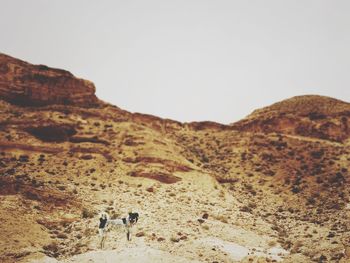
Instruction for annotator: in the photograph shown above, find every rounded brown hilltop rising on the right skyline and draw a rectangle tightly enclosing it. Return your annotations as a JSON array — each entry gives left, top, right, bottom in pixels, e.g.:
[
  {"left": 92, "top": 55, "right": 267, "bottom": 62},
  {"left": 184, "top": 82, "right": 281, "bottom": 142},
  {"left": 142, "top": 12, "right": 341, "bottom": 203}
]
[{"left": 232, "top": 95, "right": 350, "bottom": 142}]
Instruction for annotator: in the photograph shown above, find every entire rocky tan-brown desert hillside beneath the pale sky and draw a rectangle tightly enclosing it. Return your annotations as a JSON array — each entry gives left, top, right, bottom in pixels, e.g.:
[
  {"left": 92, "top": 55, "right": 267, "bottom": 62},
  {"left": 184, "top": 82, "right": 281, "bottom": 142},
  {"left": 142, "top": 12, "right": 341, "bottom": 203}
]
[{"left": 0, "top": 54, "right": 350, "bottom": 262}]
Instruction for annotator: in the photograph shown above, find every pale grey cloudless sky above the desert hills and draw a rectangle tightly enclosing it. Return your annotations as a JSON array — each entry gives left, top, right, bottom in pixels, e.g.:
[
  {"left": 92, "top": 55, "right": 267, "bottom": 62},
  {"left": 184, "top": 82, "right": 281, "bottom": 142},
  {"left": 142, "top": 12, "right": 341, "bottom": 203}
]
[{"left": 0, "top": 0, "right": 350, "bottom": 123}]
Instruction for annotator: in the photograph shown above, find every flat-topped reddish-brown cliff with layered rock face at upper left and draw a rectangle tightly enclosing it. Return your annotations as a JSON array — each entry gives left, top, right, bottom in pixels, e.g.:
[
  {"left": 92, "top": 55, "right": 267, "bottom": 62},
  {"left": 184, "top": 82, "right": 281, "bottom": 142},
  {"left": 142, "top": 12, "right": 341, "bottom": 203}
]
[{"left": 0, "top": 53, "right": 98, "bottom": 107}]
